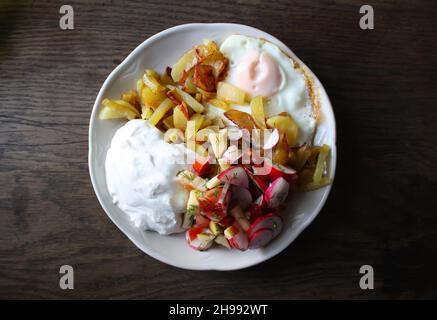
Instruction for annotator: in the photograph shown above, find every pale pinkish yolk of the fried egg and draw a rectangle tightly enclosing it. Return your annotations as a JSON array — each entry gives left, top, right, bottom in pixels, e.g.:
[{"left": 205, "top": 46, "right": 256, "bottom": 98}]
[{"left": 235, "top": 51, "right": 282, "bottom": 98}]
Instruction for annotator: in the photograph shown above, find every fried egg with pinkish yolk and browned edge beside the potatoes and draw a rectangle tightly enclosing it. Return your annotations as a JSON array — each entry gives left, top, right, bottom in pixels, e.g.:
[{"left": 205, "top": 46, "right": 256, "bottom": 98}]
[{"left": 211, "top": 35, "right": 316, "bottom": 144}]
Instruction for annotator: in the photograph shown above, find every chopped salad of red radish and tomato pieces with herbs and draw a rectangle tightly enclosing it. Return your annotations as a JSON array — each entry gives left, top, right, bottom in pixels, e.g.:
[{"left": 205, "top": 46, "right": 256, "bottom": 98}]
[{"left": 178, "top": 159, "right": 297, "bottom": 251}]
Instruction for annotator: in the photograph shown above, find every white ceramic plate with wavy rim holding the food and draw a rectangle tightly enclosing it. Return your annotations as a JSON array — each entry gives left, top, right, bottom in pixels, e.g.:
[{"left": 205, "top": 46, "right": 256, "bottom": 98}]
[{"left": 88, "top": 23, "right": 336, "bottom": 270}]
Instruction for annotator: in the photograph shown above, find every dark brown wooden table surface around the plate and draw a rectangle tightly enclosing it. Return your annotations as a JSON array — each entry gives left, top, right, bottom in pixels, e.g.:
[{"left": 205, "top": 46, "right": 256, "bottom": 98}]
[{"left": 0, "top": 0, "right": 437, "bottom": 299}]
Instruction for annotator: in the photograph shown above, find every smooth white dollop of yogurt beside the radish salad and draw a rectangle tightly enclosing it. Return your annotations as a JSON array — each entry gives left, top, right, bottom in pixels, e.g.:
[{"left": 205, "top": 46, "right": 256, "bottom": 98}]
[{"left": 105, "top": 120, "right": 188, "bottom": 234}]
